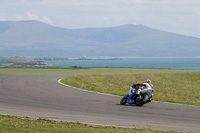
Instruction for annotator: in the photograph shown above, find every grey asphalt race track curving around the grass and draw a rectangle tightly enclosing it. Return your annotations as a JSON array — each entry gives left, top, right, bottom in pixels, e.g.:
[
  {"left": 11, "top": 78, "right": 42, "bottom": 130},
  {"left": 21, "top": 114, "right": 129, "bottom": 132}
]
[{"left": 0, "top": 75, "right": 200, "bottom": 132}]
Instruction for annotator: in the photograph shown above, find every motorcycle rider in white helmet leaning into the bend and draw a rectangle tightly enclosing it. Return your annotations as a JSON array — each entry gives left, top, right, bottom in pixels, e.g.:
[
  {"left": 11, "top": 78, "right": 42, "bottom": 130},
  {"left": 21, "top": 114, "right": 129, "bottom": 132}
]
[{"left": 129, "top": 79, "right": 153, "bottom": 97}]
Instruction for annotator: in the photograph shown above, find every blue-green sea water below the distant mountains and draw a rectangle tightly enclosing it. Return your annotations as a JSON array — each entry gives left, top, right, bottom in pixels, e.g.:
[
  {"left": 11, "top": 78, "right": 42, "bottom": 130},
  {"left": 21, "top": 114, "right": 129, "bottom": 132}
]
[{"left": 47, "top": 58, "right": 200, "bottom": 70}]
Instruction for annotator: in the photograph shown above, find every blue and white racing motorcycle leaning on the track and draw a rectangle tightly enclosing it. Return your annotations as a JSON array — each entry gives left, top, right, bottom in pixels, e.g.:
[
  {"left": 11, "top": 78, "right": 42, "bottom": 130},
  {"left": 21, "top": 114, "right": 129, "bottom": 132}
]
[{"left": 120, "top": 86, "right": 155, "bottom": 106}]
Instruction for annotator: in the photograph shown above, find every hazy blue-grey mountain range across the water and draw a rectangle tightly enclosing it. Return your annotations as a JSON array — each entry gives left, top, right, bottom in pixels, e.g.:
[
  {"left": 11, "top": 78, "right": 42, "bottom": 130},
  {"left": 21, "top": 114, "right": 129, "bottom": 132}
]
[{"left": 0, "top": 20, "right": 200, "bottom": 57}]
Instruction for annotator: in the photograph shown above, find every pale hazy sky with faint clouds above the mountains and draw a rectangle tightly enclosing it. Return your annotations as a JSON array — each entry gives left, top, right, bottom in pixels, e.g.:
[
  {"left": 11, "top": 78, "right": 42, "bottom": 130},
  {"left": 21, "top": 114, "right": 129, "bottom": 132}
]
[{"left": 0, "top": 0, "right": 200, "bottom": 38}]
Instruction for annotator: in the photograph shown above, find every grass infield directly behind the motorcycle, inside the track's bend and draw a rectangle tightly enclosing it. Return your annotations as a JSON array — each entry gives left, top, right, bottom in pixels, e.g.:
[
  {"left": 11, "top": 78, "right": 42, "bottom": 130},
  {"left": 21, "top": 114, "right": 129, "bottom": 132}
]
[{"left": 62, "top": 73, "right": 200, "bottom": 106}]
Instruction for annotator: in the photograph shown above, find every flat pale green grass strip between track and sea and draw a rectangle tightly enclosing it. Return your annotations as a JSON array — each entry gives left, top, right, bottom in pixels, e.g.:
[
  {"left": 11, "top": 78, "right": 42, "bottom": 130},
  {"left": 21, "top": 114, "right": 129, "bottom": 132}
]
[{"left": 0, "top": 67, "right": 200, "bottom": 76}]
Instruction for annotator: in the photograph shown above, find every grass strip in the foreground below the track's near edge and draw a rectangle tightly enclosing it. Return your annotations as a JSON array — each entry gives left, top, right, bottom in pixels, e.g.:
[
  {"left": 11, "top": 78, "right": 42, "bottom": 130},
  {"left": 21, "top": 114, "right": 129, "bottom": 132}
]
[{"left": 0, "top": 115, "right": 183, "bottom": 133}]
